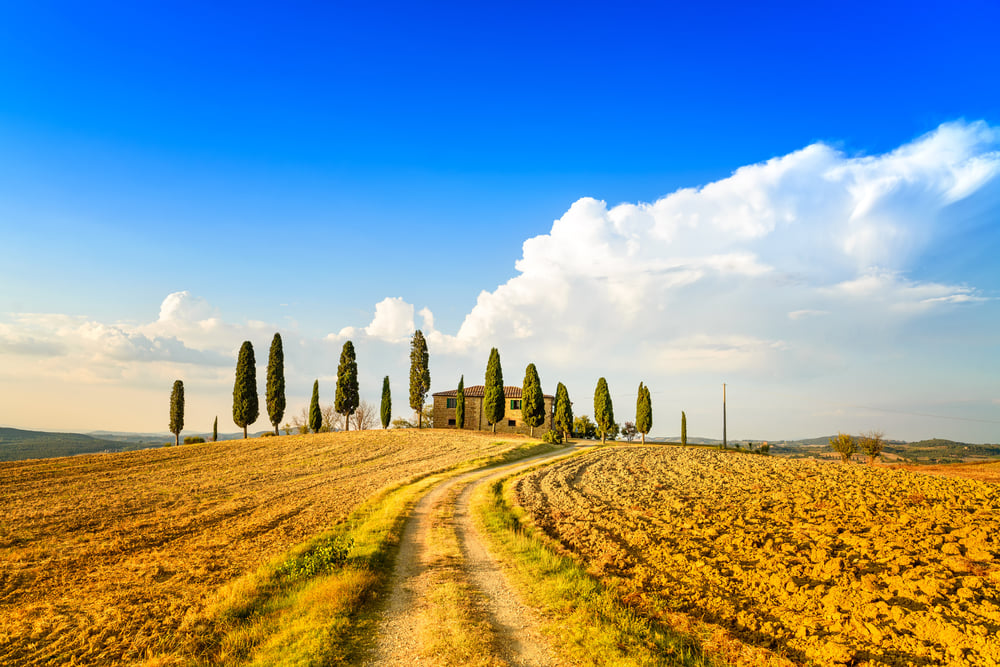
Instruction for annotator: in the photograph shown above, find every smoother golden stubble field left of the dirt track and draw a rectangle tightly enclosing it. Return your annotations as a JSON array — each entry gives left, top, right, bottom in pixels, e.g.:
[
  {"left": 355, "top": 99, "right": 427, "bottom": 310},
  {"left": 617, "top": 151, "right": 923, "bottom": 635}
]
[{"left": 0, "top": 430, "right": 518, "bottom": 665}]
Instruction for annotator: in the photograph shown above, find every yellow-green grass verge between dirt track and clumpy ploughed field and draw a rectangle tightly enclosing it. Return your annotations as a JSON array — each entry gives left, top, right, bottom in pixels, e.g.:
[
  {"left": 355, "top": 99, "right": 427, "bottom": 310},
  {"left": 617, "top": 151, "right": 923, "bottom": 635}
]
[{"left": 472, "top": 477, "right": 716, "bottom": 667}]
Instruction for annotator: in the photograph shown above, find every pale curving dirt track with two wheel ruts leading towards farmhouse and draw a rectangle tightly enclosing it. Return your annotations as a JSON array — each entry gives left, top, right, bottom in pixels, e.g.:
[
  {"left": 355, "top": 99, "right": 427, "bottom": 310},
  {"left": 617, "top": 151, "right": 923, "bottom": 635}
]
[{"left": 364, "top": 448, "right": 575, "bottom": 667}]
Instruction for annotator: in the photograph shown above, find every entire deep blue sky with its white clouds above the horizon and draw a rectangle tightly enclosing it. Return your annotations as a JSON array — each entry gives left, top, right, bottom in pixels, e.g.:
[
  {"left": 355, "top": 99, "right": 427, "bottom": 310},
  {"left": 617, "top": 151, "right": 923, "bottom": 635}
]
[{"left": 0, "top": 2, "right": 1000, "bottom": 442}]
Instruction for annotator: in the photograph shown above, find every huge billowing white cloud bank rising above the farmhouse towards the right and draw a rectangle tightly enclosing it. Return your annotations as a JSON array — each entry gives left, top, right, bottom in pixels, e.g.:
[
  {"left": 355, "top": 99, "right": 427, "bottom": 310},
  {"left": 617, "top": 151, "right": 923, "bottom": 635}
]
[{"left": 340, "top": 122, "right": 1000, "bottom": 380}]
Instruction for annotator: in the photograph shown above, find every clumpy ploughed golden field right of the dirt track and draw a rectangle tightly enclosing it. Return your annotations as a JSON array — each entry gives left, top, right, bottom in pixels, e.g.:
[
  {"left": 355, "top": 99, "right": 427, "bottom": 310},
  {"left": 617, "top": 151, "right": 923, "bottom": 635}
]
[{"left": 513, "top": 446, "right": 1000, "bottom": 665}]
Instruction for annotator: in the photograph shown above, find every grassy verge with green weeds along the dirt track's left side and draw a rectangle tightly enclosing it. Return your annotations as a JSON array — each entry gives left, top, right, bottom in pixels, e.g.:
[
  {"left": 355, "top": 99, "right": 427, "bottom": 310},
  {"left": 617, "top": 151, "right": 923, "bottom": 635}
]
[{"left": 144, "top": 443, "right": 556, "bottom": 667}]
